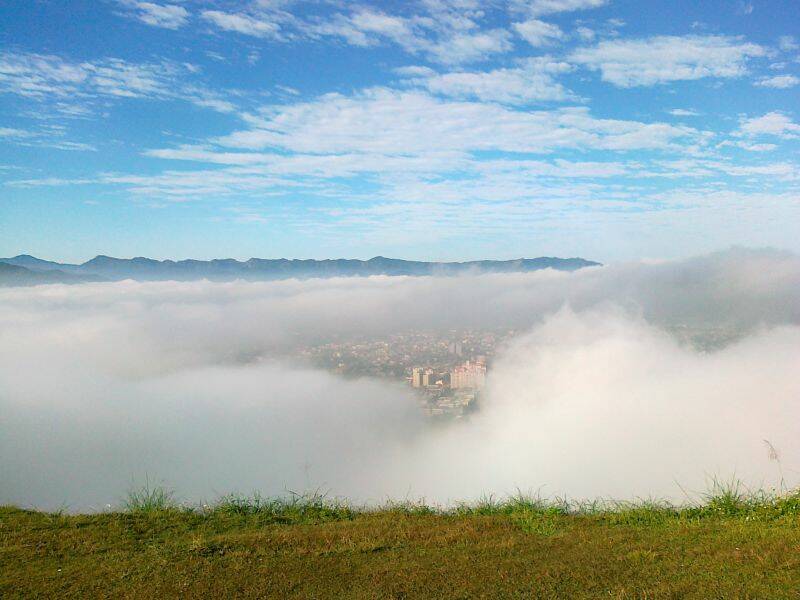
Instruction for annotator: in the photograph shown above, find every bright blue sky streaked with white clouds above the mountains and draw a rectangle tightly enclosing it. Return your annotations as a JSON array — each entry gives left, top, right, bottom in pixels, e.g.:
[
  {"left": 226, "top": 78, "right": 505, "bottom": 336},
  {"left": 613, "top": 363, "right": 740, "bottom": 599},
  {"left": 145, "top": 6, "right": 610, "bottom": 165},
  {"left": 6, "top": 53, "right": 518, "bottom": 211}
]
[{"left": 0, "top": 0, "right": 800, "bottom": 261}]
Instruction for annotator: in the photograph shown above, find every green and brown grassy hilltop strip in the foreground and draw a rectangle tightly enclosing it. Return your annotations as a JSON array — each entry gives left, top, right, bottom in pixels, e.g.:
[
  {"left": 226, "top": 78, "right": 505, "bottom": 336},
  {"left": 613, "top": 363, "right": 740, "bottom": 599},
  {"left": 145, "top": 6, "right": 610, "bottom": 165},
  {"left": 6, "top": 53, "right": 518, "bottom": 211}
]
[{"left": 0, "top": 482, "right": 800, "bottom": 598}]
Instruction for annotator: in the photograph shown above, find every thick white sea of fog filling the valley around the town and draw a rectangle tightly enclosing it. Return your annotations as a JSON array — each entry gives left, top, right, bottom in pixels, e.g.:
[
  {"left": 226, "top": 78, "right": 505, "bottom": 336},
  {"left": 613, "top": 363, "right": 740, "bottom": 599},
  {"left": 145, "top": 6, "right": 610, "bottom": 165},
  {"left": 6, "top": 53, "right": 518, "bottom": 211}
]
[{"left": 0, "top": 249, "right": 800, "bottom": 510}]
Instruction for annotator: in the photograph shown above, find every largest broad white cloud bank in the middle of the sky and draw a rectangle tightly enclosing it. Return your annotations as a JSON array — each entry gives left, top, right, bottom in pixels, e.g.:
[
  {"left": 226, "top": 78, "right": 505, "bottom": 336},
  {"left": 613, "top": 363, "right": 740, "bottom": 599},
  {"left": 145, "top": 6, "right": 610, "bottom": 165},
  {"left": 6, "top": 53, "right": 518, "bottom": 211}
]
[{"left": 216, "top": 88, "right": 699, "bottom": 154}]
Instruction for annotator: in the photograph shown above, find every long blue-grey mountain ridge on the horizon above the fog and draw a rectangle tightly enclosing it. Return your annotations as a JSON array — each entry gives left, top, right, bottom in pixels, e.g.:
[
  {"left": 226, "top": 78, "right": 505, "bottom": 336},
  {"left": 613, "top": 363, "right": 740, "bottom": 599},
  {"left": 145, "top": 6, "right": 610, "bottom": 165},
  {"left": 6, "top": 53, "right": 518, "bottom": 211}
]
[{"left": 0, "top": 254, "right": 600, "bottom": 285}]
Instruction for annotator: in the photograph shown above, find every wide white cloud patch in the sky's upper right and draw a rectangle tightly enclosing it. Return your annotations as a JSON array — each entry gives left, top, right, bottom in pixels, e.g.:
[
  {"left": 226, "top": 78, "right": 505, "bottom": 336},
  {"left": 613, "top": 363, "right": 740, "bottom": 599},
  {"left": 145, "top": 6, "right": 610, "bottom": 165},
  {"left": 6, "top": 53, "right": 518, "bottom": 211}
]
[{"left": 569, "top": 35, "right": 767, "bottom": 87}]
